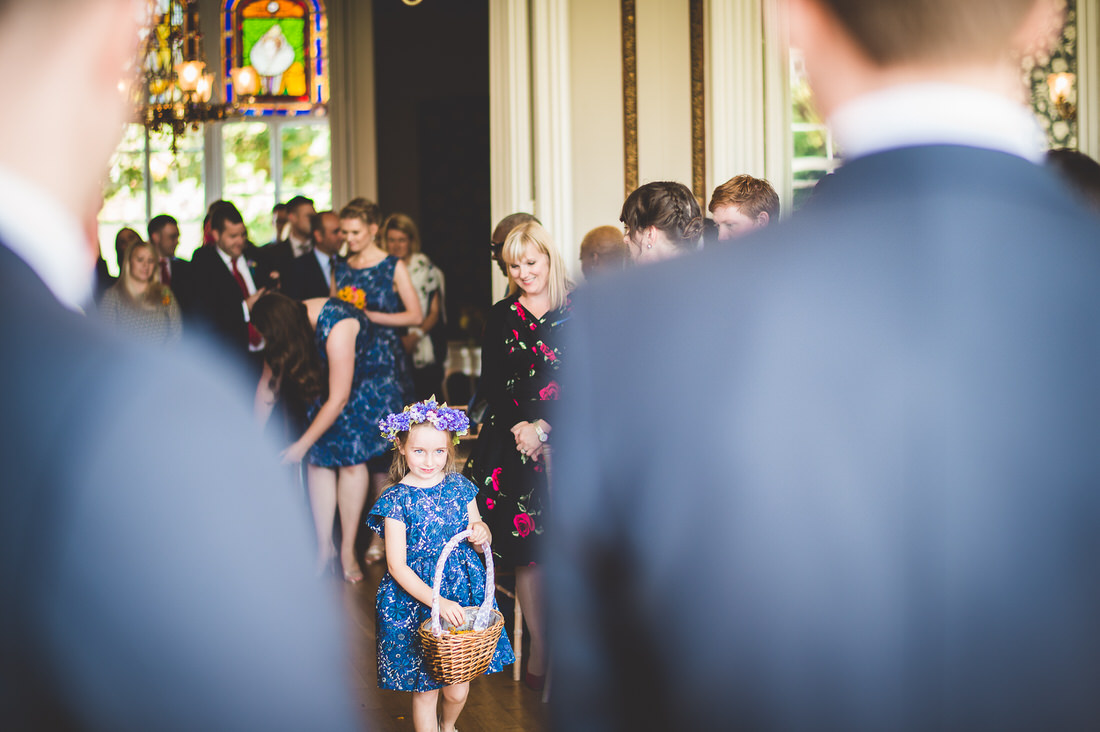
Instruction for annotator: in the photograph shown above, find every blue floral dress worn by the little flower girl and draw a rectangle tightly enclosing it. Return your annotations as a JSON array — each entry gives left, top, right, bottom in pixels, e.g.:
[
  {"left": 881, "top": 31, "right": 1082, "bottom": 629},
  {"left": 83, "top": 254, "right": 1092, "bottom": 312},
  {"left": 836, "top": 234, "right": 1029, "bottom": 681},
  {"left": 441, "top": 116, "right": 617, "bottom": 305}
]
[{"left": 366, "top": 473, "right": 516, "bottom": 691}]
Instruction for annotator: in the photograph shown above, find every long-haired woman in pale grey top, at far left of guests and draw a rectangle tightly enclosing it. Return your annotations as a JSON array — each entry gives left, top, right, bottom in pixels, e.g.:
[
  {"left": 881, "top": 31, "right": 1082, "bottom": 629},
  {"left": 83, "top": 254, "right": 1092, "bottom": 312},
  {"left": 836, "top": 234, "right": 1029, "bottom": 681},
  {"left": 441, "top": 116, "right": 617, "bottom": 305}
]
[{"left": 99, "top": 239, "right": 180, "bottom": 345}]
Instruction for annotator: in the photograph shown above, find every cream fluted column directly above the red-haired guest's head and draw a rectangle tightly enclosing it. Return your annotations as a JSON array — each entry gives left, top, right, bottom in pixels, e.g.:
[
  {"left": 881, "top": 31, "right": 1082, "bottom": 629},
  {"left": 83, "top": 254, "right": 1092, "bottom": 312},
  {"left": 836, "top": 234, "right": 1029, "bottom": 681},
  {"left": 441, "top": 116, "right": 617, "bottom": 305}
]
[{"left": 704, "top": 0, "right": 767, "bottom": 193}]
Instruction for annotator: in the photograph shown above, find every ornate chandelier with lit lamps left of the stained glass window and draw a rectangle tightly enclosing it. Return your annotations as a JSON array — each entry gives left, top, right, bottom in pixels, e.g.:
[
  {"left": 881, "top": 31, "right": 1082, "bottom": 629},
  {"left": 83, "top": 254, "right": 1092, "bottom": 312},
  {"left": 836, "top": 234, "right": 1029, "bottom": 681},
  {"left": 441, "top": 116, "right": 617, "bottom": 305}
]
[{"left": 134, "top": 0, "right": 229, "bottom": 152}]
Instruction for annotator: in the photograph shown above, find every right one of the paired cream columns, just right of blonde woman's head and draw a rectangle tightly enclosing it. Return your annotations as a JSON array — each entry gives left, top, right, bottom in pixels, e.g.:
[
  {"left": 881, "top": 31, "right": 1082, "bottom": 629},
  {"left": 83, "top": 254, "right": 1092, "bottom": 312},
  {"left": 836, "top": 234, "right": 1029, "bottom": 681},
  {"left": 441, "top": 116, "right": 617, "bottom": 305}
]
[{"left": 531, "top": 0, "right": 580, "bottom": 265}]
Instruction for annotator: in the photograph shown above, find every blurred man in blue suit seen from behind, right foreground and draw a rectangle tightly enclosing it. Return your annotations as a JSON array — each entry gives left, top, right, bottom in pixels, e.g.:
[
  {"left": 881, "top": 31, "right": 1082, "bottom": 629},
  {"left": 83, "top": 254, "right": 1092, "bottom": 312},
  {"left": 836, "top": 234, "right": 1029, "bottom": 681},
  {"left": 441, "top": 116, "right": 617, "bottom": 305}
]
[{"left": 547, "top": 0, "right": 1100, "bottom": 732}]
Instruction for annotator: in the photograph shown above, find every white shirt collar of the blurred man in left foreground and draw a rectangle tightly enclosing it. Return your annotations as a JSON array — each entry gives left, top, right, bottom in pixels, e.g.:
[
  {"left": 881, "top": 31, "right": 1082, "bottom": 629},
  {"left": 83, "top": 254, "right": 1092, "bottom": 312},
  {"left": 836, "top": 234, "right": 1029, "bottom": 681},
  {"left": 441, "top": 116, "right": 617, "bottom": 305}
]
[{"left": 0, "top": 166, "right": 95, "bottom": 310}]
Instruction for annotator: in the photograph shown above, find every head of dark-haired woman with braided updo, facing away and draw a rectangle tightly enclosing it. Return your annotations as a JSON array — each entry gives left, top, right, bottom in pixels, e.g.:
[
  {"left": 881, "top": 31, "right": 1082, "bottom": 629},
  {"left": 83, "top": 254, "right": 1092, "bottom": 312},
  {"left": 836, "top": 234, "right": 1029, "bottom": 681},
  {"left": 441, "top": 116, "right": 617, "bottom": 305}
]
[{"left": 619, "top": 181, "right": 703, "bottom": 263}]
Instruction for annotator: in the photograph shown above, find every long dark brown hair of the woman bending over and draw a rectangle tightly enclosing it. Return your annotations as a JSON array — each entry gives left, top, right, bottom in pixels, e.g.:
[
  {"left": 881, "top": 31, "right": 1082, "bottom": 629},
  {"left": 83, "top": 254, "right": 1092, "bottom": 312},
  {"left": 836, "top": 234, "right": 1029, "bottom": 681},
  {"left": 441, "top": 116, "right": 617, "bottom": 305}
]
[{"left": 252, "top": 293, "right": 322, "bottom": 405}]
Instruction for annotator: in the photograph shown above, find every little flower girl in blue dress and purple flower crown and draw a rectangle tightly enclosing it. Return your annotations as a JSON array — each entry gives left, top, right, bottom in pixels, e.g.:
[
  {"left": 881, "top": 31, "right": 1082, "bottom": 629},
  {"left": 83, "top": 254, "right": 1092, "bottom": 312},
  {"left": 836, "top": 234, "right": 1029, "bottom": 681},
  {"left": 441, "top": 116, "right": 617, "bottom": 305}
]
[{"left": 367, "top": 398, "right": 515, "bottom": 732}]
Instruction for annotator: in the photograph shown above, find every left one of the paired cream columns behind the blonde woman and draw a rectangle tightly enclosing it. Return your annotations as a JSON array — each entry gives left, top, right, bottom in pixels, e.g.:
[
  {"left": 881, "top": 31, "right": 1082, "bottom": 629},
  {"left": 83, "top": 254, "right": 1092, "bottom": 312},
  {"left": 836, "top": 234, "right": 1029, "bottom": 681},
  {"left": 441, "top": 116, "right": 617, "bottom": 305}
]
[{"left": 485, "top": 0, "right": 535, "bottom": 302}]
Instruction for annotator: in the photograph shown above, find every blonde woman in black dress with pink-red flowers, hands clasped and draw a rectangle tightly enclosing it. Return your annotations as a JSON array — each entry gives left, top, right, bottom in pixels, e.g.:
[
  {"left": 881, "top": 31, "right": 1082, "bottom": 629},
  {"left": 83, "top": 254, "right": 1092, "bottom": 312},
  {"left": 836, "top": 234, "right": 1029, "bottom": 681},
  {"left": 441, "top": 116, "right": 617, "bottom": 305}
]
[{"left": 465, "top": 221, "right": 572, "bottom": 689}]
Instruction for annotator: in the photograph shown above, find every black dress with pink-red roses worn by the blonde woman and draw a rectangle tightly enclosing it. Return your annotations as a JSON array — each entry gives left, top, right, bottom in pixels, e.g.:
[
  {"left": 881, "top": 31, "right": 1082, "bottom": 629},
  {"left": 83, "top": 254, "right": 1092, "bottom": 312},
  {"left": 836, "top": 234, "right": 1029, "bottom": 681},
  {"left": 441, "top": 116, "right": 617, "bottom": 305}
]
[{"left": 464, "top": 295, "right": 572, "bottom": 567}]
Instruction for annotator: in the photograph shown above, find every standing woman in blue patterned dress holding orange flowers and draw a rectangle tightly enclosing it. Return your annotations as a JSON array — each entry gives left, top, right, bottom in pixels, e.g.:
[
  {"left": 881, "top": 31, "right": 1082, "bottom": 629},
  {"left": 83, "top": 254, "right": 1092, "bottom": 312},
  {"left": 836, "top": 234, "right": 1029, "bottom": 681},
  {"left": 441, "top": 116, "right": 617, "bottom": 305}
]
[{"left": 332, "top": 199, "right": 424, "bottom": 564}]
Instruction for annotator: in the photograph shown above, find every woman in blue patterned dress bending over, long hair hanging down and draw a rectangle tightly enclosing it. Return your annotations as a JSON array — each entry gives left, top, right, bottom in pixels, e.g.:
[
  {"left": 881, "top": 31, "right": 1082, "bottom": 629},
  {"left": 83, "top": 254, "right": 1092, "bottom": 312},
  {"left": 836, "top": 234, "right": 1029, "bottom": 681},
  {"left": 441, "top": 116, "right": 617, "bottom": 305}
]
[{"left": 252, "top": 293, "right": 411, "bottom": 583}]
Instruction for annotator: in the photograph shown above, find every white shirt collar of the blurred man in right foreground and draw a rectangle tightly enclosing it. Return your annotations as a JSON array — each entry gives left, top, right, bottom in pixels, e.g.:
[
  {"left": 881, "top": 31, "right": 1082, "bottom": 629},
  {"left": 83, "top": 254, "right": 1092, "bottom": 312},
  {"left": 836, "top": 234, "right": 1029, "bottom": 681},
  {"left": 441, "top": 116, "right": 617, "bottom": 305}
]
[{"left": 828, "top": 83, "right": 1046, "bottom": 163}]
